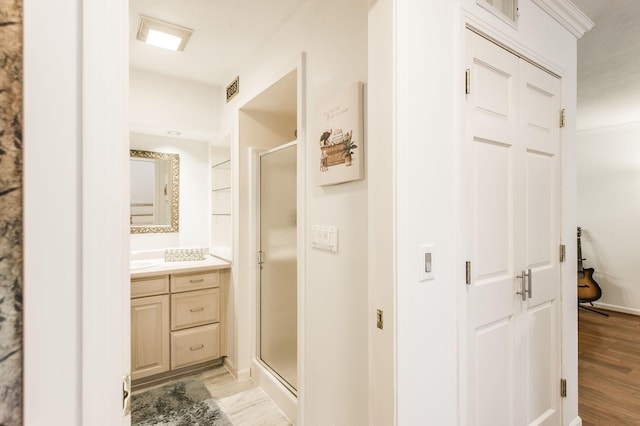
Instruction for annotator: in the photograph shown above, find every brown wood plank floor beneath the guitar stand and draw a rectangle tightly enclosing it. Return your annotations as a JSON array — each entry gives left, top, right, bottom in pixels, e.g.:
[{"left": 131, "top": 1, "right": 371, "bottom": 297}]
[{"left": 578, "top": 309, "right": 640, "bottom": 426}]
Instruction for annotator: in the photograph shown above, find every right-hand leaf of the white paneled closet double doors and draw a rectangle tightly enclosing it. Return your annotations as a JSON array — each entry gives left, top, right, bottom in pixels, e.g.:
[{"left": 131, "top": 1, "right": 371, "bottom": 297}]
[{"left": 516, "top": 55, "right": 562, "bottom": 425}]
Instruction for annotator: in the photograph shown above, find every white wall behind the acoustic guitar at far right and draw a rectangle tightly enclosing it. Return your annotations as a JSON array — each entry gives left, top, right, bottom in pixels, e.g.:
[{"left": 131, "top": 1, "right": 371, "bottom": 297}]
[{"left": 576, "top": 123, "right": 640, "bottom": 314}]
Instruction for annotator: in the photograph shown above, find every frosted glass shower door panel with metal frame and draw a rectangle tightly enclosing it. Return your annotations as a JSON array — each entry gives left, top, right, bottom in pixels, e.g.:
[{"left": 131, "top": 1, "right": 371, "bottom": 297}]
[{"left": 258, "top": 142, "right": 298, "bottom": 393}]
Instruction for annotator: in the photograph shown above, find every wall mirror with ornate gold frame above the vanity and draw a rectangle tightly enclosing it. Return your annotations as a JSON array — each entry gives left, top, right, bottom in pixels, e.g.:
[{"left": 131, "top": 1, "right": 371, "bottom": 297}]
[{"left": 129, "top": 149, "right": 180, "bottom": 234}]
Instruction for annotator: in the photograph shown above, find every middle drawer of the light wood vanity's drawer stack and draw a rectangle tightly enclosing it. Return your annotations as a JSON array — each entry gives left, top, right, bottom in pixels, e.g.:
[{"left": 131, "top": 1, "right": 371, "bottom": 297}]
[{"left": 171, "top": 288, "right": 220, "bottom": 330}]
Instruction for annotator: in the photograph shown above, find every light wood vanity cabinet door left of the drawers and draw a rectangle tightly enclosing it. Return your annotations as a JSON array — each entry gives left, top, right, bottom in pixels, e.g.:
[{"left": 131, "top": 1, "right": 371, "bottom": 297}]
[{"left": 131, "top": 294, "right": 169, "bottom": 380}]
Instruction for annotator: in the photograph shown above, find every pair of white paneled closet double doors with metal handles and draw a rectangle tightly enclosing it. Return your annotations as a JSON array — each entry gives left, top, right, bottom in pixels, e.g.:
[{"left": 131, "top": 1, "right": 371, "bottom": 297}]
[{"left": 463, "top": 31, "right": 560, "bottom": 426}]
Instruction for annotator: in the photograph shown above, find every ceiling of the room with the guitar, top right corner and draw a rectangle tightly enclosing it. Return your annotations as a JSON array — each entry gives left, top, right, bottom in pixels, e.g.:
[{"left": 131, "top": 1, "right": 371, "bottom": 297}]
[{"left": 572, "top": 0, "right": 640, "bottom": 130}]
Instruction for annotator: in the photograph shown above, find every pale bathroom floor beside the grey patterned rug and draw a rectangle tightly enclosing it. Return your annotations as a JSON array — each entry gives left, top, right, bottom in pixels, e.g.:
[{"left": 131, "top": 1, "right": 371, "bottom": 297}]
[{"left": 133, "top": 365, "right": 292, "bottom": 426}]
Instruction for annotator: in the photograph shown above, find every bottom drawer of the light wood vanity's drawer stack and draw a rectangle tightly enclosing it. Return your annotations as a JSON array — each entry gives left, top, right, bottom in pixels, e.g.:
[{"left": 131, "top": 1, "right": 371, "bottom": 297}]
[{"left": 171, "top": 324, "right": 220, "bottom": 369}]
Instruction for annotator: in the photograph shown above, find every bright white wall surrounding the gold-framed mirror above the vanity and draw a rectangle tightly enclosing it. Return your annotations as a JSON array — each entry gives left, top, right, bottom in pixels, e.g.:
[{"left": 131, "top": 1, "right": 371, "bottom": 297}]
[{"left": 130, "top": 133, "right": 211, "bottom": 250}]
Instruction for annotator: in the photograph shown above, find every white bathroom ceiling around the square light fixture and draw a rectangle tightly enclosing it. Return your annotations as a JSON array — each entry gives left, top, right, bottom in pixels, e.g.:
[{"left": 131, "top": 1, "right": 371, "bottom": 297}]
[{"left": 129, "top": 0, "right": 307, "bottom": 87}]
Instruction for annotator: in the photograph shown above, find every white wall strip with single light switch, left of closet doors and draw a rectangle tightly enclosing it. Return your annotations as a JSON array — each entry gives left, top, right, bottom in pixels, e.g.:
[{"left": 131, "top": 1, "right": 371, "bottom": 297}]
[{"left": 395, "top": 0, "right": 462, "bottom": 425}]
